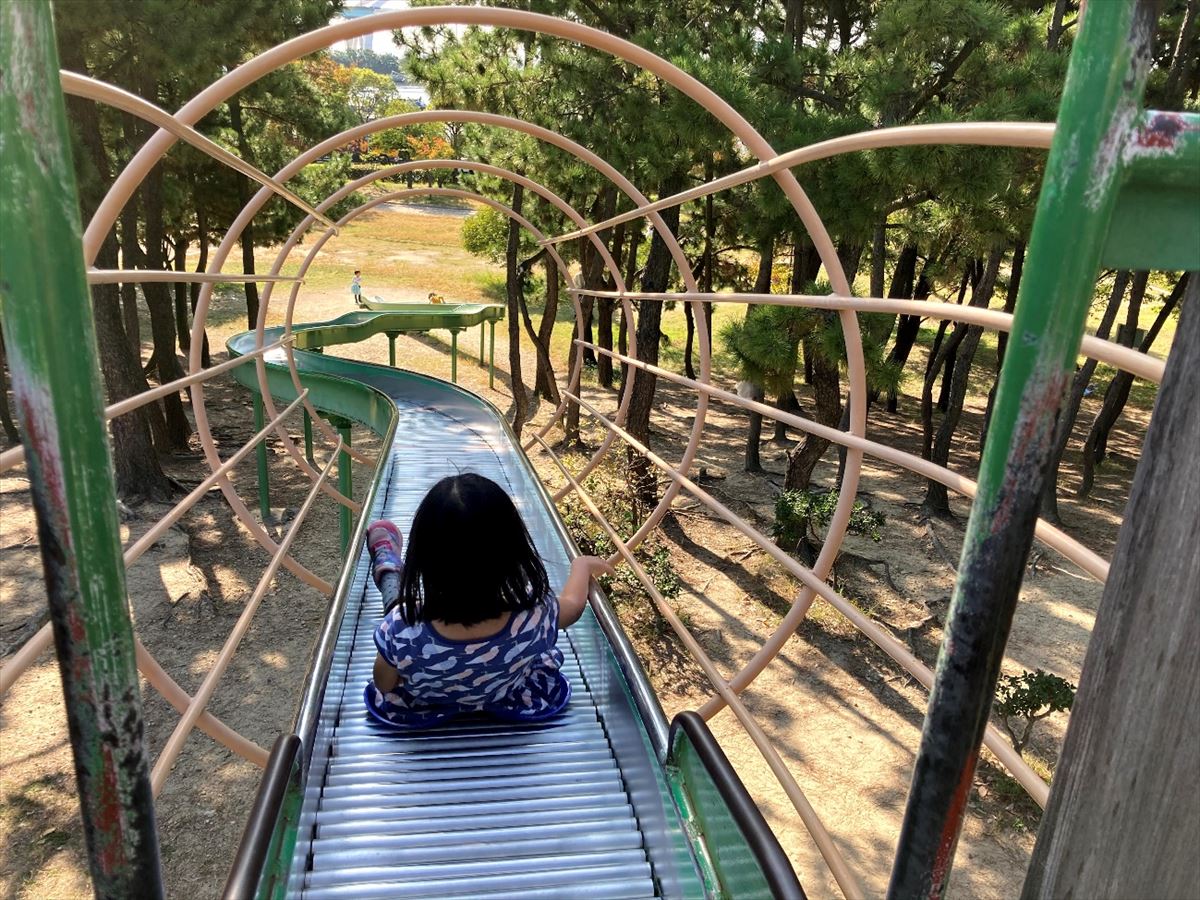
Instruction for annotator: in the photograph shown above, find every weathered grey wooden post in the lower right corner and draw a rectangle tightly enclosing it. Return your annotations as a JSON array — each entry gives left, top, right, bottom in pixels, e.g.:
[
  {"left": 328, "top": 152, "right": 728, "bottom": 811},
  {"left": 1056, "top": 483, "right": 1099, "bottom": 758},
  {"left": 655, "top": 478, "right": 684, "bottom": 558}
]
[{"left": 1021, "top": 278, "right": 1200, "bottom": 900}]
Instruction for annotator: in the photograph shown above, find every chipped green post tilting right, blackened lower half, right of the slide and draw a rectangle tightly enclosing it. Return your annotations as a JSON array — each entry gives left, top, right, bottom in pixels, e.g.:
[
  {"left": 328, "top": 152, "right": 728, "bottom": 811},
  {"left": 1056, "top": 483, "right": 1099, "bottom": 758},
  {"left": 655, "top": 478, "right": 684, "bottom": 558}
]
[{"left": 888, "top": 0, "right": 1154, "bottom": 898}]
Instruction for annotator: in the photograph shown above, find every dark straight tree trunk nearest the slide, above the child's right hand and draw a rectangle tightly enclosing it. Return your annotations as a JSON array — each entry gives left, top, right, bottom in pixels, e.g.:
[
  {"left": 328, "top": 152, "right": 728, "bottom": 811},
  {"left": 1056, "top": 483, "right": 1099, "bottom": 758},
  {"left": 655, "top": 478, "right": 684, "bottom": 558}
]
[{"left": 626, "top": 174, "right": 683, "bottom": 509}]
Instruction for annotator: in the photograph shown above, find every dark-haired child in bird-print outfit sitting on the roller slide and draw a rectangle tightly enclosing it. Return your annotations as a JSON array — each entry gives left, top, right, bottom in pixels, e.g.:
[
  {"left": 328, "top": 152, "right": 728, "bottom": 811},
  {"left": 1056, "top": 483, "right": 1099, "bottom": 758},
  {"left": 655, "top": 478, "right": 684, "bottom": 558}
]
[{"left": 364, "top": 473, "right": 613, "bottom": 727}]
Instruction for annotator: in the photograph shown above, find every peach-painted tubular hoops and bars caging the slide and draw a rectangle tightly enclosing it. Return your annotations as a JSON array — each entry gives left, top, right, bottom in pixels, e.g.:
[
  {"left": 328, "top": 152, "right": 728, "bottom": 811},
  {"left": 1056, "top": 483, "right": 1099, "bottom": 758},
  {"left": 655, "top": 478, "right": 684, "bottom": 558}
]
[{"left": 0, "top": 4, "right": 1185, "bottom": 896}]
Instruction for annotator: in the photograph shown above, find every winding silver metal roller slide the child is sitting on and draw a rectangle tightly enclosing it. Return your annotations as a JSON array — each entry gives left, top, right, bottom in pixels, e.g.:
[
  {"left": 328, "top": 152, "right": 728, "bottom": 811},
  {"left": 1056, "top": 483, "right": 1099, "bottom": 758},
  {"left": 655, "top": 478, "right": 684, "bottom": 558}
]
[{"left": 226, "top": 313, "right": 800, "bottom": 900}]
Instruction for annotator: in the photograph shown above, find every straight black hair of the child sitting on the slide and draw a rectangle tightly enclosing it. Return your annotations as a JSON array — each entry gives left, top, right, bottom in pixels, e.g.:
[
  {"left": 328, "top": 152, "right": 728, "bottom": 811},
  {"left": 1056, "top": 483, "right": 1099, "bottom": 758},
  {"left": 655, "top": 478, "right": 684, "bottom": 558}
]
[{"left": 398, "top": 472, "right": 550, "bottom": 626}]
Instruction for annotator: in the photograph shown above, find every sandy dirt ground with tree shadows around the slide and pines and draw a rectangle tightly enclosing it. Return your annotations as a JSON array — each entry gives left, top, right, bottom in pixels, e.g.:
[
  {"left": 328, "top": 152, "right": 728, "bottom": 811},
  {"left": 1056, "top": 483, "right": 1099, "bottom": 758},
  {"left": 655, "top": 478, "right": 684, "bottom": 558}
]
[{"left": 0, "top": 206, "right": 1146, "bottom": 900}]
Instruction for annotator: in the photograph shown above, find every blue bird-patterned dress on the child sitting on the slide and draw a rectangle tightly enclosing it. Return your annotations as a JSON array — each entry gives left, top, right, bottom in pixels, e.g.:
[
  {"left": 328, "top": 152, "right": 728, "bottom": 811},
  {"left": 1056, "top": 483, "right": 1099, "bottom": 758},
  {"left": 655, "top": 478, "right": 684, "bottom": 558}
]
[{"left": 364, "top": 596, "right": 571, "bottom": 728}]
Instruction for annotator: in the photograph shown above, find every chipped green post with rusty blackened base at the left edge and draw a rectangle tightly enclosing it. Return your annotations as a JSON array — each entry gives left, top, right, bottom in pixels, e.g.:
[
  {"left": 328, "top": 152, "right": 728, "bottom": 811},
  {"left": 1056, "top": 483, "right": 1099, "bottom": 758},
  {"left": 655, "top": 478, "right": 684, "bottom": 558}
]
[{"left": 0, "top": 1, "right": 162, "bottom": 898}]
